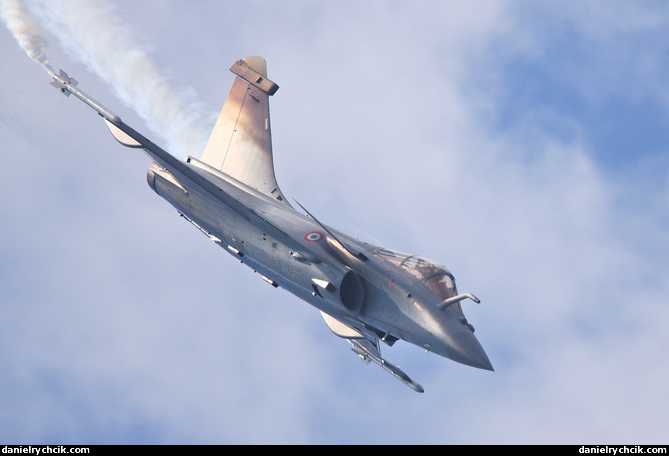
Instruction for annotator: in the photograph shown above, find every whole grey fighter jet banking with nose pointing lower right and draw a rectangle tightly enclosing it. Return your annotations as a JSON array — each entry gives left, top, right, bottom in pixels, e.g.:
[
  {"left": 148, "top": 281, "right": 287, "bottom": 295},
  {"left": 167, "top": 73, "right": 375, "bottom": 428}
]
[{"left": 51, "top": 57, "right": 493, "bottom": 393}]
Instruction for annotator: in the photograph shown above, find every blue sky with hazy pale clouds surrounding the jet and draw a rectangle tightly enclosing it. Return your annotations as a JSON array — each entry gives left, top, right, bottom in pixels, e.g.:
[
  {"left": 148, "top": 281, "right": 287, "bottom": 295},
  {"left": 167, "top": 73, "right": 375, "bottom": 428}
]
[{"left": 0, "top": 0, "right": 669, "bottom": 444}]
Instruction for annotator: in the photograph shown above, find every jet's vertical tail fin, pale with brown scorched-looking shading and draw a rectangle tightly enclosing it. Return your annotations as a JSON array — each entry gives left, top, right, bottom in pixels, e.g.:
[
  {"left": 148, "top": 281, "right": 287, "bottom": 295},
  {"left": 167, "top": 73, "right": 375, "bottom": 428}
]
[{"left": 202, "top": 57, "right": 288, "bottom": 204}]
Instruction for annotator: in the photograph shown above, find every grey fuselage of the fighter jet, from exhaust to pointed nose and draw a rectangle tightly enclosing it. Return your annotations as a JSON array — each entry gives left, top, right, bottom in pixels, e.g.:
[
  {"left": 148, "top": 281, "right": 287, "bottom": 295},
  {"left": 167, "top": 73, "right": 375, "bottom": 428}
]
[{"left": 147, "top": 158, "right": 492, "bottom": 370}]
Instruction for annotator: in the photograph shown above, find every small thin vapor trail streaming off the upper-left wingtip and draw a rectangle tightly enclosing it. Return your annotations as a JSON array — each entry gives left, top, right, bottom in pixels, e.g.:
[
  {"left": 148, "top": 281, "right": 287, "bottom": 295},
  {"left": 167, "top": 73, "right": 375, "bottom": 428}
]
[{"left": 0, "top": 0, "right": 53, "bottom": 74}]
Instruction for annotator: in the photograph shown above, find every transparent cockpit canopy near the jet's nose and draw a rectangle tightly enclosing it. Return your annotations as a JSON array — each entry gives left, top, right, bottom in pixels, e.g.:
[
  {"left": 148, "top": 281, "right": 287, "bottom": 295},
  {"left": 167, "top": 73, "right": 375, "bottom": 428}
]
[{"left": 374, "top": 249, "right": 460, "bottom": 308}]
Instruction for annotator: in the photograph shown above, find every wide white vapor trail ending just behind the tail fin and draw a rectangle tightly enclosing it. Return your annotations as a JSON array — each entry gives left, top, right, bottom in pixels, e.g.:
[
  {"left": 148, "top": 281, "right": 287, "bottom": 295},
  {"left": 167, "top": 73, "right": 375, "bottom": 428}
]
[{"left": 9, "top": 0, "right": 211, "bottom": 157}]
